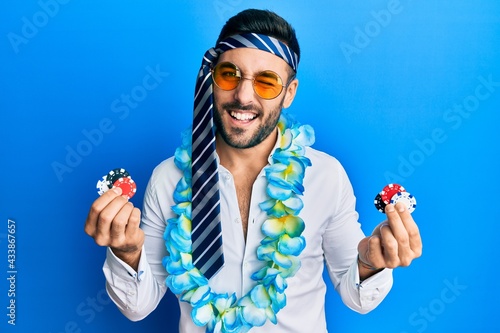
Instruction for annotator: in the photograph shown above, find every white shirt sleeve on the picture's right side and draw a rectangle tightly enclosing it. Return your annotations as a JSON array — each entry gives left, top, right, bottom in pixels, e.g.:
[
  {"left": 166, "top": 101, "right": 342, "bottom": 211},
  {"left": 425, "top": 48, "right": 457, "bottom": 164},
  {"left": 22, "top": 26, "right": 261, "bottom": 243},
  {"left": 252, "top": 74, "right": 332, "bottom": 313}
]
[{"left": 323, "top": 160, "right": 393, "bottom": 314}]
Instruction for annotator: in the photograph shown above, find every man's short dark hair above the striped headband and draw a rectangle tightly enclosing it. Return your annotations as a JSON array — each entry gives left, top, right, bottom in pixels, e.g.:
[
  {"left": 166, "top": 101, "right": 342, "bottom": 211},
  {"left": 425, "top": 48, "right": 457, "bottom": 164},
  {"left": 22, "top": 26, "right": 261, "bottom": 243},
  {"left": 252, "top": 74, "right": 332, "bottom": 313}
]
[{"left": 217, "top": 9, "right": 300, "bottom": 67}]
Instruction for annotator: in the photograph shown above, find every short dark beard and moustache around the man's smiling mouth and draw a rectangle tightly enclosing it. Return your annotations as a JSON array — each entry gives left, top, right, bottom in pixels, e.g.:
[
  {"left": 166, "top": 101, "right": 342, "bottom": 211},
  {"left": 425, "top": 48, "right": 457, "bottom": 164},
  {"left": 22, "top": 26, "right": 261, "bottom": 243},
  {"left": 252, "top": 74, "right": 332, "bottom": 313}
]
[{"left": 214, "top": 96, "right": 285, "bottom": 149}]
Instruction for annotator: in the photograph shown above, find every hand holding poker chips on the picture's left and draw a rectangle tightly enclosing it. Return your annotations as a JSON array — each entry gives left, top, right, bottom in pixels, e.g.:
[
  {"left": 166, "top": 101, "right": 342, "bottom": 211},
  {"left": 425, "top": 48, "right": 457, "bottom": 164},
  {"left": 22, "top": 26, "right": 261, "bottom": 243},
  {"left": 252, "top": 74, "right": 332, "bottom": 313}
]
[{"left": 85, "top": 187, "right": 144, "bottom": 270}]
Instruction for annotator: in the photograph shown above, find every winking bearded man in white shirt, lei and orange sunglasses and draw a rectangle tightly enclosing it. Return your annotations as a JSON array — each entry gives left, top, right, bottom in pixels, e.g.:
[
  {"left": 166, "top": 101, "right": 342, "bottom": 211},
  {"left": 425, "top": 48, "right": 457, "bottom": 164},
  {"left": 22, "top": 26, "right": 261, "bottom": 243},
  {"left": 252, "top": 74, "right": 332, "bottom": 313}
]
[{"left": 85, "top": 10, "right": 422, "bottom": 333}]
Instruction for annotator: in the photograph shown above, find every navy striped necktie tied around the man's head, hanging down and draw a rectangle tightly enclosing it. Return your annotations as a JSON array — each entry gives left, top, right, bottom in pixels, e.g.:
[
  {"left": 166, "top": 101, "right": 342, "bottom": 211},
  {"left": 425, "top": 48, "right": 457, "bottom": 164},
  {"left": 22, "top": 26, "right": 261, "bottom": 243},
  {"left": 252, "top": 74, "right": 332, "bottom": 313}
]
[{"left": 191, "top": 33, "right": 298, "bottom": 279}]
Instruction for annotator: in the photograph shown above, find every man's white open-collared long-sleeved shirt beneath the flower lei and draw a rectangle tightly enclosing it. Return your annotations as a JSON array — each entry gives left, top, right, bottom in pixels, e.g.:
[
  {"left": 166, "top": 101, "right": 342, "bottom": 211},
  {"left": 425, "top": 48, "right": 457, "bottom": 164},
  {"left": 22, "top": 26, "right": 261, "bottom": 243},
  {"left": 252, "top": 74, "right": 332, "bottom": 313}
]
[{"left": 103, "top": 134, "right": 392, "bottom": 333}]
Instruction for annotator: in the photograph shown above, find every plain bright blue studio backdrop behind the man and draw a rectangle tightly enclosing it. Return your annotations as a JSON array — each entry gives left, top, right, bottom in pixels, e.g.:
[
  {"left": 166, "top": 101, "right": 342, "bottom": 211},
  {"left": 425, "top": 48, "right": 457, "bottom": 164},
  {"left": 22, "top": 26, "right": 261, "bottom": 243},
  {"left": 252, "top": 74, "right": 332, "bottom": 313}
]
[{"left": 0, "top": 0, "right": 500, "bottom": 333}]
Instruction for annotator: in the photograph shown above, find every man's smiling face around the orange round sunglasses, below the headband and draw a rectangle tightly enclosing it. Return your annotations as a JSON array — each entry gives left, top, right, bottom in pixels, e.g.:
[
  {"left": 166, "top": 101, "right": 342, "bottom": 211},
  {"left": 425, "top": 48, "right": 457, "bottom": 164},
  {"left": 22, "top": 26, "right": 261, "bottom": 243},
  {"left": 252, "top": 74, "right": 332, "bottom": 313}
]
[{"left": 214, "top": 48, "right": 298, "bottom": 149}]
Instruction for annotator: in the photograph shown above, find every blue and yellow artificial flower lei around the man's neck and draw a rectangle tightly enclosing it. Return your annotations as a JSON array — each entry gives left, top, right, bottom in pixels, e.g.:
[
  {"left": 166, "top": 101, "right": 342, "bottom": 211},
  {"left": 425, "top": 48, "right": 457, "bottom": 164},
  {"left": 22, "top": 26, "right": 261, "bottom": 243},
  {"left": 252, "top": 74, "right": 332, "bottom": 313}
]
[{"left": 163, "top": 112, "right": 314, "bottom": 333}]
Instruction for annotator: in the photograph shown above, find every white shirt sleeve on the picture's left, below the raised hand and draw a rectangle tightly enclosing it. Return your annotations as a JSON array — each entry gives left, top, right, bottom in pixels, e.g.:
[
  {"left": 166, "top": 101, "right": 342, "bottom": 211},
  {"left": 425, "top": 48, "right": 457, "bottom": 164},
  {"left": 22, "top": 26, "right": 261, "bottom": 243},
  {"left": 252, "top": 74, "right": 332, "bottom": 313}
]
[{"left": 103, "top": 160, "right": 175, "bottom": 321}]
